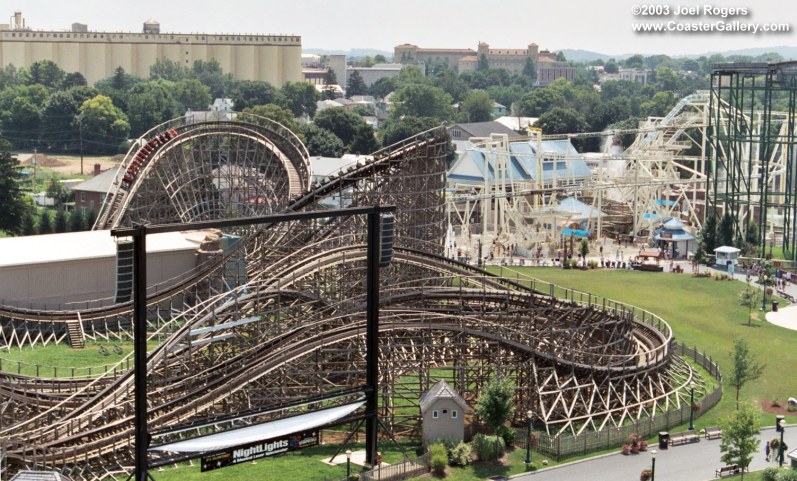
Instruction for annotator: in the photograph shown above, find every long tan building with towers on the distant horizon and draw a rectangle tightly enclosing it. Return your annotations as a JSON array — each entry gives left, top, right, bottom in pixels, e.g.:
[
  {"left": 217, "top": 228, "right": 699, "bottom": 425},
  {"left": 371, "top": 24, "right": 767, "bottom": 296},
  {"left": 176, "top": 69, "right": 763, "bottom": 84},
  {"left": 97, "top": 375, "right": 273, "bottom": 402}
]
[{"left": 393, "top": 42, "right": 576, "bottom": 86}]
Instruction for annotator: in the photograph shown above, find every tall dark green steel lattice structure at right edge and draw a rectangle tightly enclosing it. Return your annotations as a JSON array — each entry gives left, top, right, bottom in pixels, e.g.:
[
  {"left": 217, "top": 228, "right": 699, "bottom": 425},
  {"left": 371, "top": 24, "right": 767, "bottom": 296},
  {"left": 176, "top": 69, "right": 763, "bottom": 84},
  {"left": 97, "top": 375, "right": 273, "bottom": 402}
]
[{"left": 707, "top": 62, "right": 797, "bottom": 260}]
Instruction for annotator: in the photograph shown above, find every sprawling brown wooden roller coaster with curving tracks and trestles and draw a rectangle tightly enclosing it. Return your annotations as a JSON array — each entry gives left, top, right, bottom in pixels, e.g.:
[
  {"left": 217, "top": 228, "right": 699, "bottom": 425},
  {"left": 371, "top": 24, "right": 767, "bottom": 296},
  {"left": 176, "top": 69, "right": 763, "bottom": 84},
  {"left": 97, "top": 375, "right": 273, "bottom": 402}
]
[{"left": 0, "top": 116, "right": 700, "bottom": 480}]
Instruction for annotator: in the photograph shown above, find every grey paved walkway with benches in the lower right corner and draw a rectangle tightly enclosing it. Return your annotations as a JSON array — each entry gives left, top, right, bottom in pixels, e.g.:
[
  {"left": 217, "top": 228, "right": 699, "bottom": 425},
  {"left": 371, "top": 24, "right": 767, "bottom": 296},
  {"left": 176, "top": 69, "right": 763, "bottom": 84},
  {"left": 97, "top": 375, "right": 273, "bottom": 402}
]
[{"left": 512, "top": 426, "right": 797, "bottom": 481}]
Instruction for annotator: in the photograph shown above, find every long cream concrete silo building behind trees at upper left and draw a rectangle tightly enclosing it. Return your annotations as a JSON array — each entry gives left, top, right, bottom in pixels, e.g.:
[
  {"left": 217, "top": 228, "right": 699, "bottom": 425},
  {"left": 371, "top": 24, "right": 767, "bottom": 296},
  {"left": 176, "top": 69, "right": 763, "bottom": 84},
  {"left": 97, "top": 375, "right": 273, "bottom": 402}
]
[{"left": 0, "top": 12, "right": 302, "bottom": 86}]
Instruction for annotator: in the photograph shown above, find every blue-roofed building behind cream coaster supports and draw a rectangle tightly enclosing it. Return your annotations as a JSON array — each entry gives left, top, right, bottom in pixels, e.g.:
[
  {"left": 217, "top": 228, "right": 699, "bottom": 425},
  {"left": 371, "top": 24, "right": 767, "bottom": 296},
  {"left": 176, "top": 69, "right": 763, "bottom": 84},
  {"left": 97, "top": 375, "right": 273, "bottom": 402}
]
[{"left": 446, "top": 133, "right": 592, "bottom": 249}]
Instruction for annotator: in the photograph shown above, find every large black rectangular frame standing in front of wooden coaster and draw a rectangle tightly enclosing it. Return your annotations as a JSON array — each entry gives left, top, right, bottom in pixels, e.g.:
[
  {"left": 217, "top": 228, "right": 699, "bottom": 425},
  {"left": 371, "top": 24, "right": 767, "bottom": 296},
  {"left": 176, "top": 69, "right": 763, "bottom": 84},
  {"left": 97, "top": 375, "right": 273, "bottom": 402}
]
[{"left": 111, "top": 205, "right": 396, "bottom": 481}]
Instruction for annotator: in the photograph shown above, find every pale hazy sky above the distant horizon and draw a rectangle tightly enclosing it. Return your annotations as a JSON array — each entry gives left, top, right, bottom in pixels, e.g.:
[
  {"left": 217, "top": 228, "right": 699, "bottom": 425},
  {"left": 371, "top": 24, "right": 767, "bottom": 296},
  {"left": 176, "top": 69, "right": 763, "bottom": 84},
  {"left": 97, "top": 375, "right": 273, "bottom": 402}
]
[{"left": 6, "top": 0, "right": 797, "bottom": 56}]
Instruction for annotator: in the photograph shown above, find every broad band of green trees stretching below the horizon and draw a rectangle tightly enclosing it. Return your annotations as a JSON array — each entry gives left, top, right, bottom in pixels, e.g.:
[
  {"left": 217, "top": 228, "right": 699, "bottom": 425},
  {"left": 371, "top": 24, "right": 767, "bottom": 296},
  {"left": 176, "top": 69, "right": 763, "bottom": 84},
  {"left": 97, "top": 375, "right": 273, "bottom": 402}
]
[{"left": 0, "top": 49, "right": 782, "bottom": 233}]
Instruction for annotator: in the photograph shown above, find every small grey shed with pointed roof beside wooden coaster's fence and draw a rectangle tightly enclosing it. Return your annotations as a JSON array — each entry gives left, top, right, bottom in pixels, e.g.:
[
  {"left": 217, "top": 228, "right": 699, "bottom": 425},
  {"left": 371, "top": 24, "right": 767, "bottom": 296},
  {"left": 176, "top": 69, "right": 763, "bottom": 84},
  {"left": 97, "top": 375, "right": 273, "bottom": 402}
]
[{"left": 421, "top": 381, "right": 470, "bottom": 444}]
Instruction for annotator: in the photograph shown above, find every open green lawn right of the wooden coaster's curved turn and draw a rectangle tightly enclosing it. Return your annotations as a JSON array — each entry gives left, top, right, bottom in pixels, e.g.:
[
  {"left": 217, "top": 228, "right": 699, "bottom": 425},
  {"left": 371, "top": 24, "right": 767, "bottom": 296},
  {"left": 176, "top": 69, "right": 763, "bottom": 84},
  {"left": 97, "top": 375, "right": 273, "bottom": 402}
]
[{"left": 492, "top": 267, "right": 797, "bottom": 425}]
